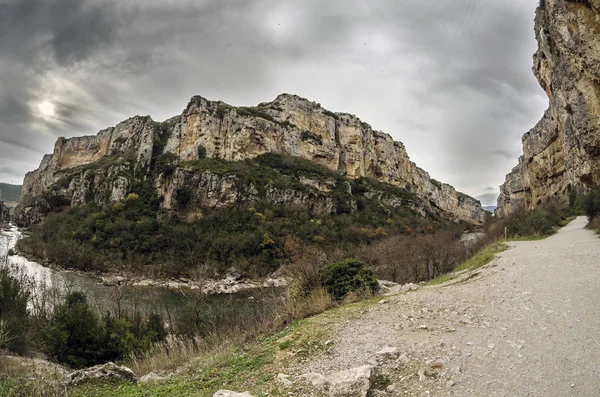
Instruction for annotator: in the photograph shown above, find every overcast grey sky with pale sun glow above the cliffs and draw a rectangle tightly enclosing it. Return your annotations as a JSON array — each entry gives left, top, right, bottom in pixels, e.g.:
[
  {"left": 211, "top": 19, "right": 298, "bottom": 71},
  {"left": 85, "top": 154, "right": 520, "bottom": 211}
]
[{"left": 0, "top": 0, "right": 548, "bottom": 204}]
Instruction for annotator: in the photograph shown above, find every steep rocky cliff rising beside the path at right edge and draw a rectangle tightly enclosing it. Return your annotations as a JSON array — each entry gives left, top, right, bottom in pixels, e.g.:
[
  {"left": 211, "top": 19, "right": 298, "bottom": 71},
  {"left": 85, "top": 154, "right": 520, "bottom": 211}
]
[{"left": 497, "top": 0, "right": 600, "bottom": 215}]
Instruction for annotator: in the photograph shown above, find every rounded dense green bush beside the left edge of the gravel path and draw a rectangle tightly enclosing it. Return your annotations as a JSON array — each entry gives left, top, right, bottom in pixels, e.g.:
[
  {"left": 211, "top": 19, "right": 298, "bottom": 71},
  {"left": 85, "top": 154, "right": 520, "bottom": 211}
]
[{"left": 321, "top": 259, "right": 379, "bottom": 300}]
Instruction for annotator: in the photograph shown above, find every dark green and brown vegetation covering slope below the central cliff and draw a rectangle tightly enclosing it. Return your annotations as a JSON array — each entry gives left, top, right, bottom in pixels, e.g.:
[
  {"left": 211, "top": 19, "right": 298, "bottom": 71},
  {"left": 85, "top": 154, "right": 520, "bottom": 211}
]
[{"left": 19, "top": 154, "right": 448, "bottom": 277}]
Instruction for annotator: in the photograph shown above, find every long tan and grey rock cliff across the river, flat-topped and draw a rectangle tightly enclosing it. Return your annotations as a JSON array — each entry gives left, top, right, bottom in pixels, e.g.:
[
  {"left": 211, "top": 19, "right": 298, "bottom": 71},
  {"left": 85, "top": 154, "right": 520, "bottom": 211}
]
[{"left": 16, "top": 94, "right": 485, "bottom": 225}]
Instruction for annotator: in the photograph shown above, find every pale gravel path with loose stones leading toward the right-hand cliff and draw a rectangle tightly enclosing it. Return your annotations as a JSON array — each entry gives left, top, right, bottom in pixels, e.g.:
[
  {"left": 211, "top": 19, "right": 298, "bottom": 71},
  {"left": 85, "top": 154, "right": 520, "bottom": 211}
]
[{"left": 290, "top": 217, "right": 600, "bottom": 397}]
